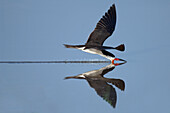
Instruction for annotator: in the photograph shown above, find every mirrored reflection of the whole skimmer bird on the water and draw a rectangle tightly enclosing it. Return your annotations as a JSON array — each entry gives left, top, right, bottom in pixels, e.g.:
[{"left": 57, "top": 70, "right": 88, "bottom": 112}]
[{"left": 65, "top": 63, "right": 125, "bottom": 108}]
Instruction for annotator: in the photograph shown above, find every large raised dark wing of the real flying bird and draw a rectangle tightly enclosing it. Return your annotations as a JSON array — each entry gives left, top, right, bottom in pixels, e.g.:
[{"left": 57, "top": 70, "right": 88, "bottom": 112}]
[{"left": 86, "top": 4, "right": 116, "bottom": 47}]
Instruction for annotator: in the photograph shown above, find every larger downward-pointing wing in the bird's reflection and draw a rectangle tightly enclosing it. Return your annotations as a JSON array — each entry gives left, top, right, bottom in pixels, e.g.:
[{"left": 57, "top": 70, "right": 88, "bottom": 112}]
[{"left": 87, "top": 78, "right": 117, "bottom": 108}]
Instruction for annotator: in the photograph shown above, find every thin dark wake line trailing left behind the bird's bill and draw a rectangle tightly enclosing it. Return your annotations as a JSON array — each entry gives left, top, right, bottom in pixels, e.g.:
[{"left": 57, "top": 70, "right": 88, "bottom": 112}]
[{"left": 0, "top": 60, "right": 110, "bottom": 64}]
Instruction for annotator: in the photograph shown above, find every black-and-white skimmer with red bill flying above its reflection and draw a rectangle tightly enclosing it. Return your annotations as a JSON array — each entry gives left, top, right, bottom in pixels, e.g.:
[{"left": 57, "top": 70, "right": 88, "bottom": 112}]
[{"left": 64, "top": 4, "right": 125, "bottom": 63}]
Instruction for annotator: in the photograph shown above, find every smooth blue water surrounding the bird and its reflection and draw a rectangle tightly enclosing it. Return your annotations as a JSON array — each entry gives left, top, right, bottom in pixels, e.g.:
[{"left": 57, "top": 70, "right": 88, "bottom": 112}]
[{"left": 0, "top": 0, "right": 170, "bottom": 113}]
